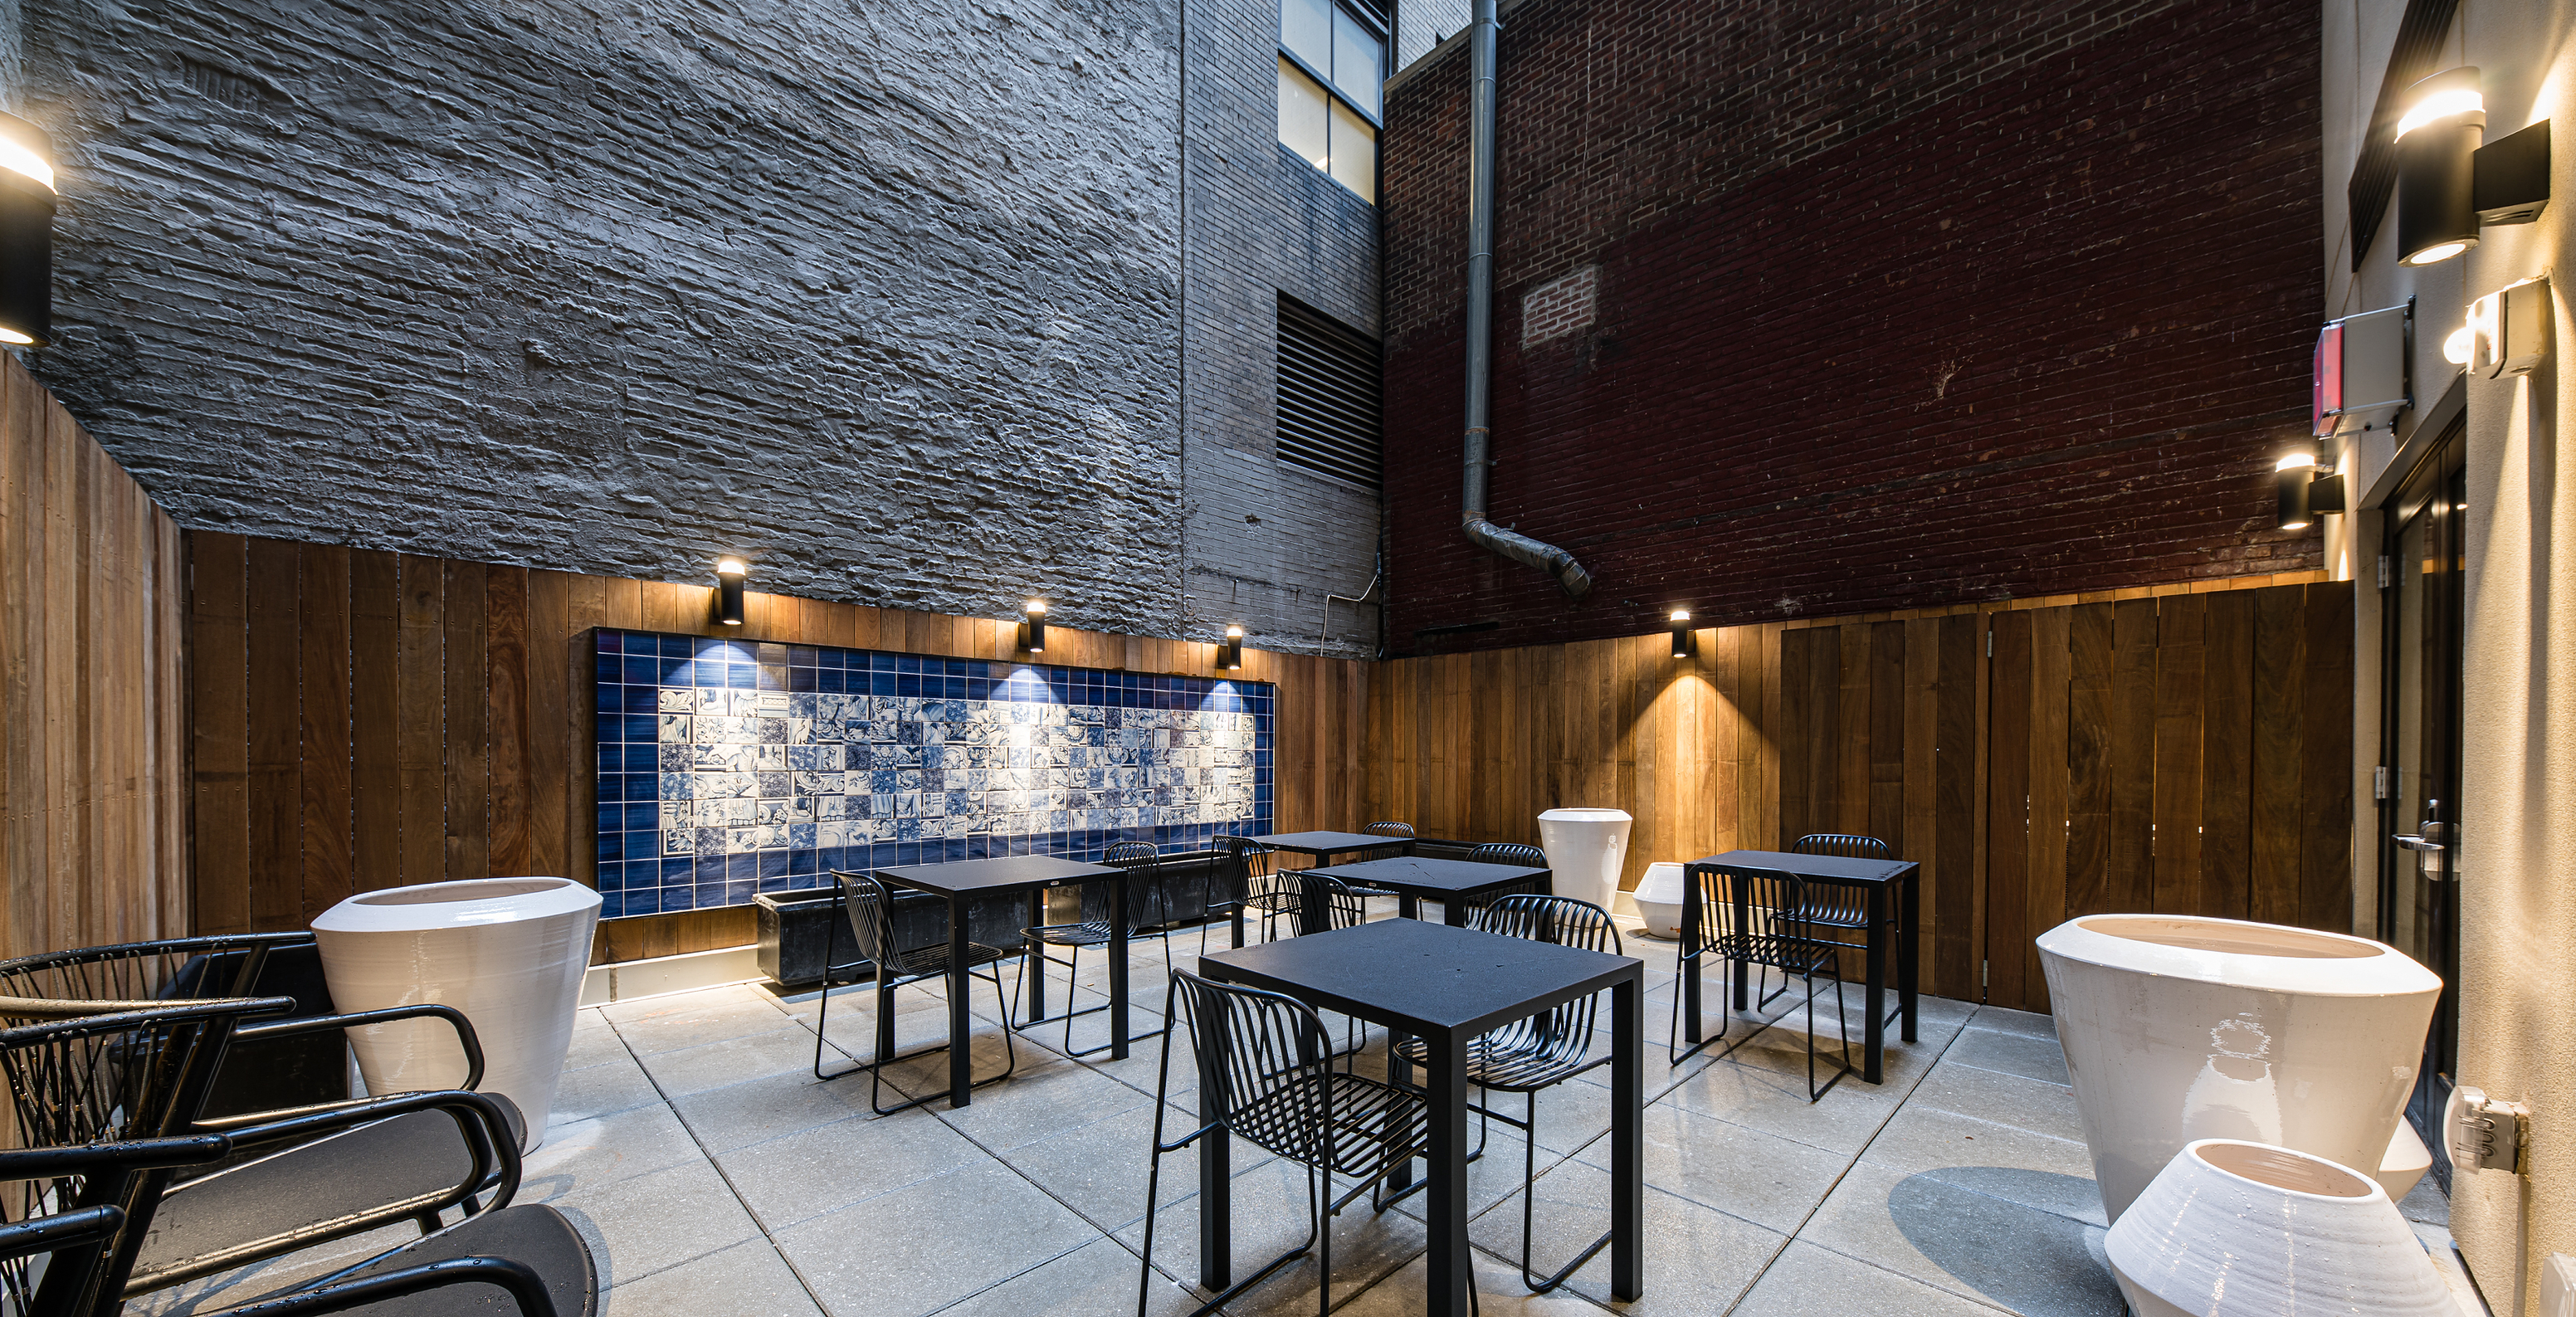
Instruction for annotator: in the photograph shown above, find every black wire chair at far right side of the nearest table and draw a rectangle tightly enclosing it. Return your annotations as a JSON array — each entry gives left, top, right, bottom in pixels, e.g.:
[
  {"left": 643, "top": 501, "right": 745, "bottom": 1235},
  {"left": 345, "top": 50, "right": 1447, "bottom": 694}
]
[{"left": 1396, "top": 895, "right": 1626, "bottom": 1294}]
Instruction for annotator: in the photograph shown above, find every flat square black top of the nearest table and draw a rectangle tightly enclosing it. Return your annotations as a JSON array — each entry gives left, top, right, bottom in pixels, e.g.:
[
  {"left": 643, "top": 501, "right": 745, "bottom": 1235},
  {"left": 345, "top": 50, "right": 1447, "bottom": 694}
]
[{"left": 1200, "top": 917, "right": 1646, "bottom": 1039}]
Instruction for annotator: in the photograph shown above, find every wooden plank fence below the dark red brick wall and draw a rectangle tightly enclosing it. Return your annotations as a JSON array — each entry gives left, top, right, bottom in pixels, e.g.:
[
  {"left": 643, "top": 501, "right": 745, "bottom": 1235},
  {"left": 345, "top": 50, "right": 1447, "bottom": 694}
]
[{"left": 1368, "top": 578, "right": 2352, "bottom": 1010}]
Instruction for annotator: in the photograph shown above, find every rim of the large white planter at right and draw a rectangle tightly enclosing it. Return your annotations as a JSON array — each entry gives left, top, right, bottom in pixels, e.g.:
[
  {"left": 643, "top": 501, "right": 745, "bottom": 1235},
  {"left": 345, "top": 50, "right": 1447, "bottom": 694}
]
[{"left": 2037, "top": 915, "right": 2442, "bottom": 998}]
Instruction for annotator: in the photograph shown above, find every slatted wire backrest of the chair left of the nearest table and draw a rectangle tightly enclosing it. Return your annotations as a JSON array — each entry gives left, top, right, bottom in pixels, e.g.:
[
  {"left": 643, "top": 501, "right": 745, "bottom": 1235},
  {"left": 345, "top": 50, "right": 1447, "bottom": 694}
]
[{"left": 1157, "top": 969, "right": 1332, "bottom": 1165}]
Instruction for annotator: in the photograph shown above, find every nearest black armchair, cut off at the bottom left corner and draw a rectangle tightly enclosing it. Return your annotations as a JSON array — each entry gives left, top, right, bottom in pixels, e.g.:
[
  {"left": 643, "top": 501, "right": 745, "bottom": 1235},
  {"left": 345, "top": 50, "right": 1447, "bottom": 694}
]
[{"left": 0, "top": 1134, "right": 600, "bottom": 1317}]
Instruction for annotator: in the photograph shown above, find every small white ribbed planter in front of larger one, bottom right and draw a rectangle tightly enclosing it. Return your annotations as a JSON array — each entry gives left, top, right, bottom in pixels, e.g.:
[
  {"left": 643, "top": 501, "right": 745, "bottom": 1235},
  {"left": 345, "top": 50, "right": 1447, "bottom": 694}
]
[{"left": 2102, "top": 1139, "right": 2455, "bottom": 1317}]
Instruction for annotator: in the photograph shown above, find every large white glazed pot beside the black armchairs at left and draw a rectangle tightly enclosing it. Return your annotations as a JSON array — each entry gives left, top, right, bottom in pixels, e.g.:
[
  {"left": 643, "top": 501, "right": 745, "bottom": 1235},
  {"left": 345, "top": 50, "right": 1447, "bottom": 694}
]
[{"left": 315, "top": 879, "right": 600, "bottom": 1147}]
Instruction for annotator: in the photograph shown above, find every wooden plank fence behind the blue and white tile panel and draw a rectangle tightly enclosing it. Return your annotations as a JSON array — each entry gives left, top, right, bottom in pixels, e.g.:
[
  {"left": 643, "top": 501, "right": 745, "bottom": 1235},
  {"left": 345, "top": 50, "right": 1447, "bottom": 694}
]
[{"left": 185, "top": 531, "right": 1368, "bottom": 961}]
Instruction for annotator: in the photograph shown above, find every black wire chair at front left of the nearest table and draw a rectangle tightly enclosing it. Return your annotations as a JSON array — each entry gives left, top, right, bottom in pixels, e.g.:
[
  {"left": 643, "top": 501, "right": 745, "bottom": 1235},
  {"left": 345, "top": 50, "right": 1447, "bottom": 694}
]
[{"left": 1136, "top": 972, "right": 1430, "bottom": 1317}]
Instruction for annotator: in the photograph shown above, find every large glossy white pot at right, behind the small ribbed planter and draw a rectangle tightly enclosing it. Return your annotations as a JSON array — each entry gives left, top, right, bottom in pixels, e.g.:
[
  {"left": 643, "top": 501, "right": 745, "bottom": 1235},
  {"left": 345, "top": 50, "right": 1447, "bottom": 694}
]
[{"left": 2037, "top": 915, "right": 2442, "bottom": 1222}]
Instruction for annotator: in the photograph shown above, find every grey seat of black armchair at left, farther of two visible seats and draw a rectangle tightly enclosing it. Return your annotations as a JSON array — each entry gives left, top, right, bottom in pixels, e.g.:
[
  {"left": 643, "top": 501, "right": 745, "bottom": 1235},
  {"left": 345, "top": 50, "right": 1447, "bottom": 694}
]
[{"left": 126, "top": 1093, "right": 518, "bottom": 1294}]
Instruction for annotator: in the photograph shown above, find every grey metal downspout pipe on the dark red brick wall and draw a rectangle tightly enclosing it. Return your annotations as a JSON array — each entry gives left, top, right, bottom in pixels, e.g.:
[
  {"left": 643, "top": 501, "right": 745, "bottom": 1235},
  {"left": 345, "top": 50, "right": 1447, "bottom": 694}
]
[{"left": 1458, "top": 0, "right": 1592, "bottom": 598}]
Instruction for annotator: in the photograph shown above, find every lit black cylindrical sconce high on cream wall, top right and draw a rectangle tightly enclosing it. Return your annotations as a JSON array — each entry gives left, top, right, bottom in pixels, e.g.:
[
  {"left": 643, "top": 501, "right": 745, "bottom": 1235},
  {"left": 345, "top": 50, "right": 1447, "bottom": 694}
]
[{"left": 2398, "top": 65, "right": 2550, "bottom": 266}]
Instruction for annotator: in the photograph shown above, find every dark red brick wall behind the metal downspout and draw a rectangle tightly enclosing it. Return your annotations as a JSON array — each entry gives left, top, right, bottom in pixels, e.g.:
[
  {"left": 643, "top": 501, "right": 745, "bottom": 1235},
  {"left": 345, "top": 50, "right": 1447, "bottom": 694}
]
[{"left": 1383, "top": 0, "right": 2324, "bottom": 652}]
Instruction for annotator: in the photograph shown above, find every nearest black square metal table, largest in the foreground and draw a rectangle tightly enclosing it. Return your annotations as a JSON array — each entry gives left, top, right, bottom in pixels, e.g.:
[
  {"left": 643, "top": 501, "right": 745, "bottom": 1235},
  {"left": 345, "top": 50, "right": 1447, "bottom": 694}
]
[{"left": 1198, "top": 920, "right": 1646, "bottom": 1317}]
